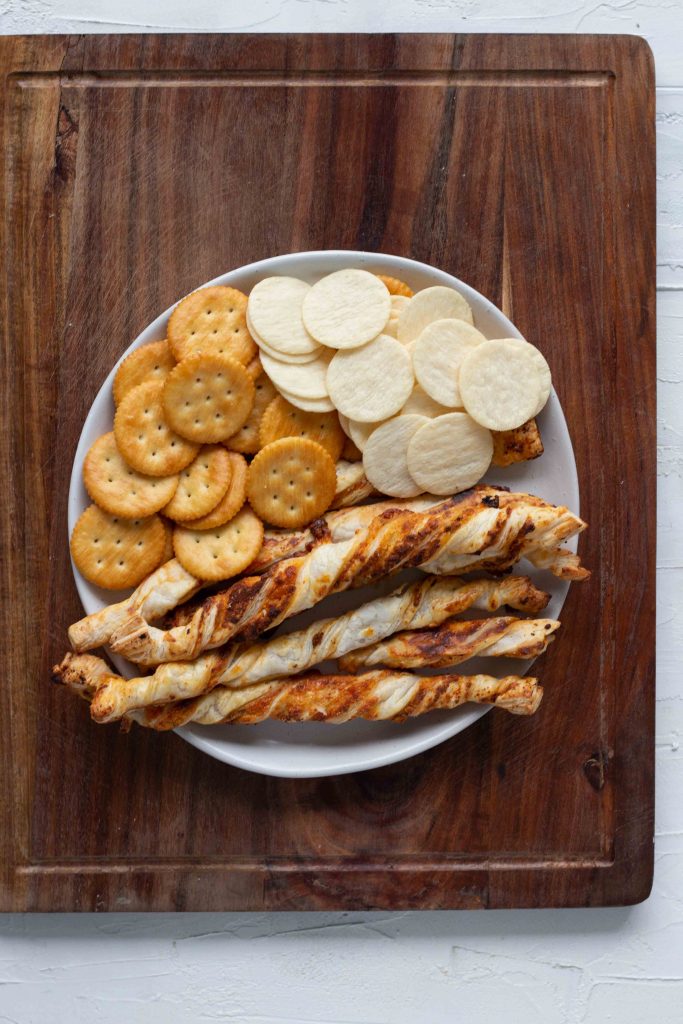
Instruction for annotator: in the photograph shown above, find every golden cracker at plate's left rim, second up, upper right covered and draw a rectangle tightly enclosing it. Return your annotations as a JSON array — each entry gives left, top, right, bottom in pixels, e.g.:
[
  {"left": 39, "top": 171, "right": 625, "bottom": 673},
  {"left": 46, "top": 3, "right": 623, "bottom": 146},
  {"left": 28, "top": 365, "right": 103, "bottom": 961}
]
[{"left": 83, "top": 431, "right": 178, "bottom": 519}]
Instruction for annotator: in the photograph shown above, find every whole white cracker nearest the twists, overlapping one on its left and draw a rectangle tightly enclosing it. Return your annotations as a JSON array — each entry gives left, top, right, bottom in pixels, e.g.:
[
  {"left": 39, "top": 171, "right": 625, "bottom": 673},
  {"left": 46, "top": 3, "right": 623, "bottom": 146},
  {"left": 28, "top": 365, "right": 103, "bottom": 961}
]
[{"left": 408, "top": 413, "right": 494, "bottom": 495}]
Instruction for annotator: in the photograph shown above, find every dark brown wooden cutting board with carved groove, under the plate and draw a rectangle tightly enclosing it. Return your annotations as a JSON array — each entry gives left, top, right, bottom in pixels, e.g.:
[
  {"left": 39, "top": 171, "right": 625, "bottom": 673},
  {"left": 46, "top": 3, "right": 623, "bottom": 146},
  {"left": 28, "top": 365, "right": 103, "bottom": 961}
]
[{"left": 0, "top": 36, "right": 655, "bottom": 910}]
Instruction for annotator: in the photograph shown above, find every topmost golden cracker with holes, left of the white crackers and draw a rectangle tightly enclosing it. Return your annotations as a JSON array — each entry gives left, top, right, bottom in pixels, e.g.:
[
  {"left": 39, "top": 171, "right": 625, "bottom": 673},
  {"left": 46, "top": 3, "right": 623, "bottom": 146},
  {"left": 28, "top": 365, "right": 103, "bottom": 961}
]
[{"left": 168, "top": 285, "right": 257, "bottom": 365}]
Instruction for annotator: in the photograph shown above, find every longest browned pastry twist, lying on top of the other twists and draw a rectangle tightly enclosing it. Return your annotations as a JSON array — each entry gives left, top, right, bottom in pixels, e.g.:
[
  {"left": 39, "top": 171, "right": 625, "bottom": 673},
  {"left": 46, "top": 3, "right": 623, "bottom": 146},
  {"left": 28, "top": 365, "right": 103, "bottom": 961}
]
[{"left": 111, "top": 488, "right": 585, "bottom": 666}]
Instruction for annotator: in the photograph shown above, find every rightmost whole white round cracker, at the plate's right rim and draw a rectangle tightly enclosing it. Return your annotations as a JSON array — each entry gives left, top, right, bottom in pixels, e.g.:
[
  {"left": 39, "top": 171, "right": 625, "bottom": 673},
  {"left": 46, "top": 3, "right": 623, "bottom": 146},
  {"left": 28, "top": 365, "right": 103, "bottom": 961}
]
[{"left": 458, "top": 338, "right": 550, "bottom": 430}]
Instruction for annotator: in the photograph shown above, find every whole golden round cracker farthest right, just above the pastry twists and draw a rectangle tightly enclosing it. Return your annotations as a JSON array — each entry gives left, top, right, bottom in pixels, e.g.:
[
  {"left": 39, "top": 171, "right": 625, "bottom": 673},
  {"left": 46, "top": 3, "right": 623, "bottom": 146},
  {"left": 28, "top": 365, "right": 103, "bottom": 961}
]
[{"left": 247, "top": 437, "right": 337, "bottom": 529}]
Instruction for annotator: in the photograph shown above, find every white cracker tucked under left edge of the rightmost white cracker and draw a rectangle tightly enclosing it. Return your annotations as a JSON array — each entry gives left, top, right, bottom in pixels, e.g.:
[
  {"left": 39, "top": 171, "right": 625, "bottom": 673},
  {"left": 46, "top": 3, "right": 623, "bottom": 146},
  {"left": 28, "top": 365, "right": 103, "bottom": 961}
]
[{"left": 411, "top": 319, "right": 486, "bottom": 409}]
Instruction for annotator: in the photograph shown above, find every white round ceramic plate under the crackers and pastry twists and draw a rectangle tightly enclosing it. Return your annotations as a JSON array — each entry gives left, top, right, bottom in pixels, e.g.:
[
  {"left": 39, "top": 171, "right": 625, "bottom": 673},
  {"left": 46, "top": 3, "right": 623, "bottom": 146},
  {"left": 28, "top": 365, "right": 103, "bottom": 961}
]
[{"left": 69, "top": 250, "right": 580, "bottom": 778}]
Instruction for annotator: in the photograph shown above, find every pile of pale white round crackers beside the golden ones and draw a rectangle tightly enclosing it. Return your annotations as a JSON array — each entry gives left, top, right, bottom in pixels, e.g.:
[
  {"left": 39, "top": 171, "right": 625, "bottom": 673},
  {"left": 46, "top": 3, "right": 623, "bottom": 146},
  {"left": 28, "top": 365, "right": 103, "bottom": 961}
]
[{"left": 247, "top": 268, "right": 551, "bottom": 497}]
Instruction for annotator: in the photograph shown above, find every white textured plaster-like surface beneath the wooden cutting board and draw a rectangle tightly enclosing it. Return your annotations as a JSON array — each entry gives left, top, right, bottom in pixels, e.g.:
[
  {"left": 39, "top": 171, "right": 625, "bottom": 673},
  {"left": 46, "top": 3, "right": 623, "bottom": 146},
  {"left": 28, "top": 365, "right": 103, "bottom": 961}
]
[{"left": 0, "top": 0, "right": 683, "bottom": 1024}]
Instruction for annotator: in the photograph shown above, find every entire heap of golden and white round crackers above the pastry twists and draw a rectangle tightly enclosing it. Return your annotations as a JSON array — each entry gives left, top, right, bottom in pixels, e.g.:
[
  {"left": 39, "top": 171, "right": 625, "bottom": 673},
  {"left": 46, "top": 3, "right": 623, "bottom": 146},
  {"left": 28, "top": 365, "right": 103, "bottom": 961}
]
[{"left": 71, "top": 268, "right": 551, "bottom": 589}]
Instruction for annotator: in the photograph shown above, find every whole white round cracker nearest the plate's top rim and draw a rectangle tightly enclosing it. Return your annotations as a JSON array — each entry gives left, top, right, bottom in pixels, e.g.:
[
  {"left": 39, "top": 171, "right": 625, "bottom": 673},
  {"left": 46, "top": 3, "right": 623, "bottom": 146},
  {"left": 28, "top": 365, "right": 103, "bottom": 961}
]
[{"left": 303, "top": 268, "right": 391, "bottom": 348}]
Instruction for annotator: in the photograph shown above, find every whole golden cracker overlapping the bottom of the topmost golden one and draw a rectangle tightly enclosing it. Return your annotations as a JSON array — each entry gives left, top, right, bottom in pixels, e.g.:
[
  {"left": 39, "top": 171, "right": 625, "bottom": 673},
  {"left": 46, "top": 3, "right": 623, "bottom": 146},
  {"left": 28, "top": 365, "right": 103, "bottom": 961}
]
[{"left": 163, "top": 352, "right": 254, "bottom": 444}]
